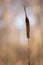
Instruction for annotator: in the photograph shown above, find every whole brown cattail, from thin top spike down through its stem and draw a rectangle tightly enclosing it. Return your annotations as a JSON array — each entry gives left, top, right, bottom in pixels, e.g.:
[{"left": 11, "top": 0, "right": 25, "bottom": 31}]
[{"left": 24, "top": 6, "right": 30, "bottom": 65}]
